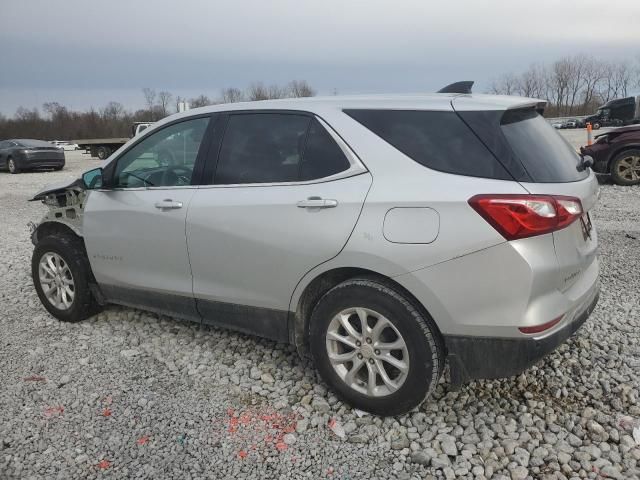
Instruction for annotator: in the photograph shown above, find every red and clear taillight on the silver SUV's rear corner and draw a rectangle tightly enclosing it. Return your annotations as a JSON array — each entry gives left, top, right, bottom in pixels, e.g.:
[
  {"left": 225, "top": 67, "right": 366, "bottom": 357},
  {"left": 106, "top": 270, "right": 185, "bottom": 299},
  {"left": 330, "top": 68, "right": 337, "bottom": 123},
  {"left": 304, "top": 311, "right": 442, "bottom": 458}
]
[{"left": 469, "top": 194, "right": 582, "bottom": 240}]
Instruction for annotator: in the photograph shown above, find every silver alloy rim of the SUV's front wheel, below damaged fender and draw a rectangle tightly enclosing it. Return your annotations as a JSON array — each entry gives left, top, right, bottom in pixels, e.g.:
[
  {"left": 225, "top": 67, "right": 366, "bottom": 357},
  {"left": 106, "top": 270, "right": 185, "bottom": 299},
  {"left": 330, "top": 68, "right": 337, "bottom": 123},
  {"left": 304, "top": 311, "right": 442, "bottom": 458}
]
[{"left": 38, "top": 252, "right": 76, "bottom": 310}]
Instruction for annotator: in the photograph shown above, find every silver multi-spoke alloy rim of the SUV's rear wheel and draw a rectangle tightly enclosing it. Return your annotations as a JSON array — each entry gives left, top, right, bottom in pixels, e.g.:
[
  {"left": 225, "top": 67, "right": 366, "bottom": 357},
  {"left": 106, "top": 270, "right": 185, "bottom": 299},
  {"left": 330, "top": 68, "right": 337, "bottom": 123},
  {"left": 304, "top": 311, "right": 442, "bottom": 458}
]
[{"left": 326, "top": 307, "right": 409, "bottom": 397}]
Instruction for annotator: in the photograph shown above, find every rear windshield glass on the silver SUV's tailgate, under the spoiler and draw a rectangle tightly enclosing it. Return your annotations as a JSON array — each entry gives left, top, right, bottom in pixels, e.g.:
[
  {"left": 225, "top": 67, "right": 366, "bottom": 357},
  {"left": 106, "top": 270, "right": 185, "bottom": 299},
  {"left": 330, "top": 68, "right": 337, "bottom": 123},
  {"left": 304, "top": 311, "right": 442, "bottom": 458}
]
[{"left": 500, "top": 109, "right": 589, "bottom": 183}]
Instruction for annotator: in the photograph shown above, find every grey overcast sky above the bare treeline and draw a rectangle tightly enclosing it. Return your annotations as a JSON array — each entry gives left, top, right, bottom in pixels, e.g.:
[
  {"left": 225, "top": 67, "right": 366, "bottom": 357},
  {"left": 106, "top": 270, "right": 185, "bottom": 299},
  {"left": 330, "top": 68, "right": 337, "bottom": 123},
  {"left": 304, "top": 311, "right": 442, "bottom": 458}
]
[{"left": 0, "top": 0, "right": 640, "bottom": 115}]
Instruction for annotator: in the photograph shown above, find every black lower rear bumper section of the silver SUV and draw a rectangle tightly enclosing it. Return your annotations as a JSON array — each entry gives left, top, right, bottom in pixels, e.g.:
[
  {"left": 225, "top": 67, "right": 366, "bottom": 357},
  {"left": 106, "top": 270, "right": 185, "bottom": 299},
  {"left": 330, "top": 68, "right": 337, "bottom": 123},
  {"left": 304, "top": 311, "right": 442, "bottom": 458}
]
[{"left": 445, "top": 284, "right": 600, "bottom": 385}]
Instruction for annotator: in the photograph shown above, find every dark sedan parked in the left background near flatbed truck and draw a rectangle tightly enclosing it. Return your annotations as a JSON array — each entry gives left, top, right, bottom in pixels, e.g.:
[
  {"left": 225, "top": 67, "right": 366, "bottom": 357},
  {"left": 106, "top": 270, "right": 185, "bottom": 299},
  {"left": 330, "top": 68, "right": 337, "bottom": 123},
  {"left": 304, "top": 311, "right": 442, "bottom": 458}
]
[{"left": 0, "top": 139, "right": 64, "bottom": 173}]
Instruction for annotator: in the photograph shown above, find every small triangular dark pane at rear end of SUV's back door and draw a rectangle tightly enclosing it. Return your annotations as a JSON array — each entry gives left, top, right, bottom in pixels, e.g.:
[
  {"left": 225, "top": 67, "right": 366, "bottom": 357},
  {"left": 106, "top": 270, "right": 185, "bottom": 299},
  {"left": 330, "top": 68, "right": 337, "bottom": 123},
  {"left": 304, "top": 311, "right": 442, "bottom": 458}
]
[{"left": 300, "top": 119, "right": 350, "bottom": 180}]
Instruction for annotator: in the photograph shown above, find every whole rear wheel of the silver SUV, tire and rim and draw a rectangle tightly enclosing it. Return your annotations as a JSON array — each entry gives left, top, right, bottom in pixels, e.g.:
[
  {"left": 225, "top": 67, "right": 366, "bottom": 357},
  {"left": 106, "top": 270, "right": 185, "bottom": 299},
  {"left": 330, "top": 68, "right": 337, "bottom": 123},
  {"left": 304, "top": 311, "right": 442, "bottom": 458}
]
[{"left": 309, "top": 278, "right": 444, "bottom": 415}]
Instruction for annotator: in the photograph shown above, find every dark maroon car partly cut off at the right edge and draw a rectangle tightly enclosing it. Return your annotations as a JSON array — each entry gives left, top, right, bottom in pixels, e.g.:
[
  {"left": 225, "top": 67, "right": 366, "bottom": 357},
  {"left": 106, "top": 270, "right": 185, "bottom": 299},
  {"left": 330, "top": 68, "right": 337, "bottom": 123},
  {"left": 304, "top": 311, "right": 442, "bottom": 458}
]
[{"left": 580, "top": 125, "right": 640, "bottom": 185}]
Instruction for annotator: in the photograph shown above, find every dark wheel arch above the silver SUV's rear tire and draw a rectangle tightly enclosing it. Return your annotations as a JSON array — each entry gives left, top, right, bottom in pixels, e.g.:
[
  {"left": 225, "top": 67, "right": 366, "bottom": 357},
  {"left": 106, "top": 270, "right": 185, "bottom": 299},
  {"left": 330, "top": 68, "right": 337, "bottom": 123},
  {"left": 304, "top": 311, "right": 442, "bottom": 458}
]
[{"left": 290, "top": 266, "right": 446, "bottom": 356}]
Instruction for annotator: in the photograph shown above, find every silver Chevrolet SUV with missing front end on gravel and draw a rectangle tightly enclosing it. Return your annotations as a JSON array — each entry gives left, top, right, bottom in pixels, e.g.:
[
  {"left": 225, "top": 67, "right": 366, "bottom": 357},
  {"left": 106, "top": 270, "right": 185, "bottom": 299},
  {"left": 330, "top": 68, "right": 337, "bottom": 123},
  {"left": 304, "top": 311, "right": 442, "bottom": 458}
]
[{"left": 32, "top": 94, "right": 599, "bottom": 415}]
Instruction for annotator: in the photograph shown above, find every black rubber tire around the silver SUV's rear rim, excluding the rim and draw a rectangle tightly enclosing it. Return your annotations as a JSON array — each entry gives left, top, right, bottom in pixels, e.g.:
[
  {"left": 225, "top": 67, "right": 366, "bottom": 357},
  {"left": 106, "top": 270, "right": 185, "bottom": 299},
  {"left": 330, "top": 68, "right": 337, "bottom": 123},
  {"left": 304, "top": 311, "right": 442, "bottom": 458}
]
[{"left": 309, "top": 278, "right": 444, "bottom": 415}]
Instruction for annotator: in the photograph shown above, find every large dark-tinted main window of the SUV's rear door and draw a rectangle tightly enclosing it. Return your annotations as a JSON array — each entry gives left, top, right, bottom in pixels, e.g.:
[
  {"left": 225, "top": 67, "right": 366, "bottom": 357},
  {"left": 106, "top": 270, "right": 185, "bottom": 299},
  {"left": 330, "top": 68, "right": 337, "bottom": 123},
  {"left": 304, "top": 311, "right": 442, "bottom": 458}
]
[{"left": 215, "top": 113, "right": 311, "bottom": 185}]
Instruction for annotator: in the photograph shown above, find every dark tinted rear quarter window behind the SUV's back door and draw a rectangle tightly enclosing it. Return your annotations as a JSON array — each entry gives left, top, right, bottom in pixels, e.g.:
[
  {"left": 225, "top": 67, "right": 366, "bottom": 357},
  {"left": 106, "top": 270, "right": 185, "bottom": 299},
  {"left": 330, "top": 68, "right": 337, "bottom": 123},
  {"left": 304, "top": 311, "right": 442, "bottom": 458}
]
[{"left": 344, "top": 110, "right": 513, "bottom": 180}]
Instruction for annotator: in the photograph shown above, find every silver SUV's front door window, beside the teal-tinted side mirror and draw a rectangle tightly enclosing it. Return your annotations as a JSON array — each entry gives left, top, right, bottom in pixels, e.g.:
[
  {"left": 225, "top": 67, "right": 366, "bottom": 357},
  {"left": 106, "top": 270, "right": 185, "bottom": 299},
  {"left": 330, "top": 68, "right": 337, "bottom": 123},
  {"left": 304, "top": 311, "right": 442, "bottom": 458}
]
[{"left": 113, "top": 118, "right": 209, "bottom": 188}]
